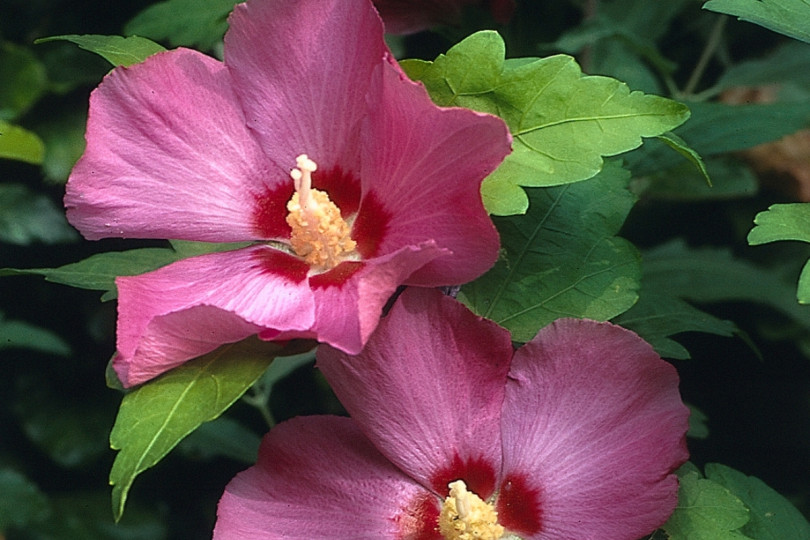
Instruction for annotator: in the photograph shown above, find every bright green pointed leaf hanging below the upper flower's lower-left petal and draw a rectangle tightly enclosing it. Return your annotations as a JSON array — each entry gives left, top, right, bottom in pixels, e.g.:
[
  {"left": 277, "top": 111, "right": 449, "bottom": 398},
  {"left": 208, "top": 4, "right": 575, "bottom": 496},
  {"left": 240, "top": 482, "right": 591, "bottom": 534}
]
[{"left": 110, "top": 339, "right": 278, "bottom": 520}]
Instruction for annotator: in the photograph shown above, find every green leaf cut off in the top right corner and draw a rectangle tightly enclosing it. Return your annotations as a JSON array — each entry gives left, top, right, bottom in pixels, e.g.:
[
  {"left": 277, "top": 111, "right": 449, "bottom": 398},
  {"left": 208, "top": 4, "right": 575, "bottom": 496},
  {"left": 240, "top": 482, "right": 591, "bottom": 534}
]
[{"left": 703, "top": 0, "right": 810, "bottom": 42}]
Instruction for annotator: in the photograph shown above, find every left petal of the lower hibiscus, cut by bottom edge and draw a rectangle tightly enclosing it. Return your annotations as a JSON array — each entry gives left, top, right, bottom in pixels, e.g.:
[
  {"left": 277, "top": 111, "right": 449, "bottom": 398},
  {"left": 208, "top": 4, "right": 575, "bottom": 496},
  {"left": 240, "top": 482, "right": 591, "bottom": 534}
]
[{"left": 214, "top": 416, "right": 438, "bottom": 540}]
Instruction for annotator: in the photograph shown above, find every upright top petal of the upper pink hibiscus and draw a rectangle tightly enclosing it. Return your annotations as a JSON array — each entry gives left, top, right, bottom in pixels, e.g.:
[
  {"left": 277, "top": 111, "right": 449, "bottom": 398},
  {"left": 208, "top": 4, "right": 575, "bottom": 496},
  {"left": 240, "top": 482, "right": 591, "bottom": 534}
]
[{"left": 225, "top": 0, "right": 388, "bottom": 174}]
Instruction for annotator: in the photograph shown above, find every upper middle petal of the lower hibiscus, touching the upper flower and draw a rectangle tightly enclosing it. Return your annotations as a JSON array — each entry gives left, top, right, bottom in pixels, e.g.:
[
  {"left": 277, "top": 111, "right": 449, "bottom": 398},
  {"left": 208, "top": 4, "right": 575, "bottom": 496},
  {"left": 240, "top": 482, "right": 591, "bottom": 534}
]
[{"left": 318, "top": 289, "right": 512, "bottom": 497}]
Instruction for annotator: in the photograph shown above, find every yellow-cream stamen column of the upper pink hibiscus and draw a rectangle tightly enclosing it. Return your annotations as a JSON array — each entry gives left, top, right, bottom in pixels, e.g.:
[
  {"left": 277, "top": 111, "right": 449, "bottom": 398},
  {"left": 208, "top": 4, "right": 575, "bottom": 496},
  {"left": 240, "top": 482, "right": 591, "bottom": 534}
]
[{"left": 287, "top": 154, "right": 357, "bottom": 271}]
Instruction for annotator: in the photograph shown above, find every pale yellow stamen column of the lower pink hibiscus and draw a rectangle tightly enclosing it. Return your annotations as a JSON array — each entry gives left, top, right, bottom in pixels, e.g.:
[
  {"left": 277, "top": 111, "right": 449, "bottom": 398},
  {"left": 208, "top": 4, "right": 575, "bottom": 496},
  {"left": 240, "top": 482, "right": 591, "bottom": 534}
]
[{"left": 439, "top": 480, "right": 505, "bottom": 540}]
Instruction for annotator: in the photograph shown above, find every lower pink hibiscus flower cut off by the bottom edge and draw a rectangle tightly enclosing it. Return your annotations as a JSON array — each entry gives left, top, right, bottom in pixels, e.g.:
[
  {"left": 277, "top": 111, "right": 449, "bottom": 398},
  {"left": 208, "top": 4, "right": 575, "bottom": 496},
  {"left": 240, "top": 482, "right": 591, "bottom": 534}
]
[{"left": 214, "top": 289, "right": 689, "bottom": 540}]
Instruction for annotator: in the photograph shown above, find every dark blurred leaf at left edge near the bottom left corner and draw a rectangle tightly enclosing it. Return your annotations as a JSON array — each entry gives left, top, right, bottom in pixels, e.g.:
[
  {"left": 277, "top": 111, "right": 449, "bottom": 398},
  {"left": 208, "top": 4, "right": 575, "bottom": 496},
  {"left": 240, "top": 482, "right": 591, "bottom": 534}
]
[{"left": 0, "top": 468, "right": 50, "bottom": 534}]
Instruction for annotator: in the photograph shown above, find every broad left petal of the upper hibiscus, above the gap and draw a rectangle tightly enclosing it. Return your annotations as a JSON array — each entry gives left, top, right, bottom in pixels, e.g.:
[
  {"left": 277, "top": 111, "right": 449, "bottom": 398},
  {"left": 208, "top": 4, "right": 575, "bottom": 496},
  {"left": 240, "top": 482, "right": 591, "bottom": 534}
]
[{"left": 65, "top": 49, "right": 278, "bottom": 242}]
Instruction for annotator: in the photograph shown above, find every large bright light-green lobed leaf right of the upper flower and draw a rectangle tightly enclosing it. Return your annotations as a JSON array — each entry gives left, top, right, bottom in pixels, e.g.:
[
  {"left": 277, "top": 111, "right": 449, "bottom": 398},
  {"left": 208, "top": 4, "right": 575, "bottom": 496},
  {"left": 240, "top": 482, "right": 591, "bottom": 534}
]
[{"left": 402, "top": 31, "right": 689, "bottom": 215}]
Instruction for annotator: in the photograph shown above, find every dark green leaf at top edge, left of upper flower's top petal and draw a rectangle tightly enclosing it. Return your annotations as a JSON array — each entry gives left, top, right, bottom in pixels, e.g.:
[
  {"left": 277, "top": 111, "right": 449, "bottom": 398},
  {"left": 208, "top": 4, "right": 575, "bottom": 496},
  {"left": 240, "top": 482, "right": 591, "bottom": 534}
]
[{"left": 124, "top": 0, "right": 238, "bottom": 50}]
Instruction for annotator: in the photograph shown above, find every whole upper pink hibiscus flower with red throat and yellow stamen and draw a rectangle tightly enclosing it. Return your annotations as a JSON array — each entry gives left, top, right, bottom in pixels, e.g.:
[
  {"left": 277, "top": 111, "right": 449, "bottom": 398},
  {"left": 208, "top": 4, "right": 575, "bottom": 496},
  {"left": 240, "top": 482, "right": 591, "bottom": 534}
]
[{"left": 65, "top": 0, "right": 504, "bottom": 386}]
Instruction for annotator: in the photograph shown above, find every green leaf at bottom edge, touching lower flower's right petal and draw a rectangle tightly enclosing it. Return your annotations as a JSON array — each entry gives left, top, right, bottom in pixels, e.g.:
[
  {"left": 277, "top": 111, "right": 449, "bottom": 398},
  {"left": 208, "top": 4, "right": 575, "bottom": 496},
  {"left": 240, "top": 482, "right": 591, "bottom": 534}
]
[{"left": 662, "top": 468, "right": 749, "bottom": 540}]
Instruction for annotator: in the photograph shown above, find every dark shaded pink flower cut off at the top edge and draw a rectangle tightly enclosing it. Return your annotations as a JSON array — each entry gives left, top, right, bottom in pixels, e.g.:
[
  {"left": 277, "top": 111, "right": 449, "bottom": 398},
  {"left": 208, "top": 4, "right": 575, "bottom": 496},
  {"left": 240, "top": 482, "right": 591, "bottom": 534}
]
[{"left": 374, "top": 0, "right": 515, "bottom": 34}]
